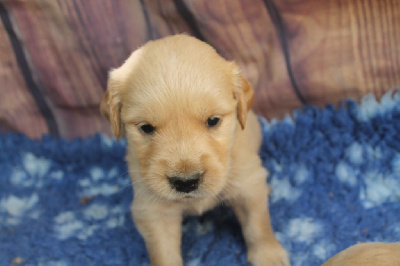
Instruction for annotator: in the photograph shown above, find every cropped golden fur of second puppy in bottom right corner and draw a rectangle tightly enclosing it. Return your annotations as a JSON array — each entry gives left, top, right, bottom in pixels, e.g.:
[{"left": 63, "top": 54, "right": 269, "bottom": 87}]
[{"left": 323, "top": 242, "right": 400, "bottom": 266}]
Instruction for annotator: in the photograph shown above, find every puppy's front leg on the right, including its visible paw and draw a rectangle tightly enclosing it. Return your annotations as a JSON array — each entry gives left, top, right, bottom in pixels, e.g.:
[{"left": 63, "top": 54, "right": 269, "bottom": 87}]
[{"left": 232, "top": 169, "right": 290, "bottom": 266}]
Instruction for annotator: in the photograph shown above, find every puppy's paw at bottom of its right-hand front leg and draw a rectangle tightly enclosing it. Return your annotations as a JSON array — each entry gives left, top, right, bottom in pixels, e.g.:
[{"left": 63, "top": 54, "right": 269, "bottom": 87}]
[{"left": 248, "top": 244, "right": 290, "bottom": 266}]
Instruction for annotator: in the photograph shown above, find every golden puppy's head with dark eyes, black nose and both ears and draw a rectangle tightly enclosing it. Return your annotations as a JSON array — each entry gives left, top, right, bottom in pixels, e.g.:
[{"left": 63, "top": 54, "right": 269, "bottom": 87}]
[{"left": 101, "top": 35, "right": 253, "bottom": 200}]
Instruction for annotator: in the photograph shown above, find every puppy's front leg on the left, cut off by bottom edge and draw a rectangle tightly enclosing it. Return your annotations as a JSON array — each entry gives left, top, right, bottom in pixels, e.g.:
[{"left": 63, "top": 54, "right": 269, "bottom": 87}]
[{"left": 132, "top": 199, "right": 183, "bottom": 266}]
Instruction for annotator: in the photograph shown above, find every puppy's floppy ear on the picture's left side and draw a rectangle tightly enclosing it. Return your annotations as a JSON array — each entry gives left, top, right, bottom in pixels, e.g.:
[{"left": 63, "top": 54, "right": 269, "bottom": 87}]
[{"left": 100, "top": 70, "right": 122, "bottom": 140}]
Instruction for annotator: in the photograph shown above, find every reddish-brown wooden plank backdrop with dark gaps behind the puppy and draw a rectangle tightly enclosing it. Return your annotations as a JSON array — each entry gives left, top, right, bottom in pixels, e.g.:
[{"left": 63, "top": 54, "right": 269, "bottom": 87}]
[{"left": 0, "top": 0, "right": 400, "bottom": 138}]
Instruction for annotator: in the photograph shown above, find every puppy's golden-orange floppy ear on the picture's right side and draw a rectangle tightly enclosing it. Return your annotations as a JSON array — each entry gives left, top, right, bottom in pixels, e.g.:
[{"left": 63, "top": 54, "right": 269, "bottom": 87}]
[{"left": 233, "top": 65, "right": 254, "bottom": 129}]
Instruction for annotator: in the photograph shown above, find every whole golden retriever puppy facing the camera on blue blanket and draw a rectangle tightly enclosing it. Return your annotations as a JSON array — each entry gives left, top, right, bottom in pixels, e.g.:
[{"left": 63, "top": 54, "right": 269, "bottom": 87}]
[{"left": 101, "top": 35, "right": 289, "bottom": 266}]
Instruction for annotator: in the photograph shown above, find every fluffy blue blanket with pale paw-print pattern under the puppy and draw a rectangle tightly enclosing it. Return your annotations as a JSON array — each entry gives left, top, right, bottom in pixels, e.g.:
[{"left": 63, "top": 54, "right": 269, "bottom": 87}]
[{"left": 0, "top": 93, "right": 400, "bottom": 266}]
